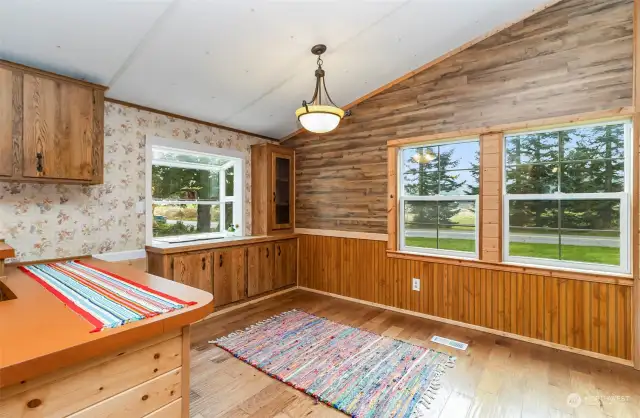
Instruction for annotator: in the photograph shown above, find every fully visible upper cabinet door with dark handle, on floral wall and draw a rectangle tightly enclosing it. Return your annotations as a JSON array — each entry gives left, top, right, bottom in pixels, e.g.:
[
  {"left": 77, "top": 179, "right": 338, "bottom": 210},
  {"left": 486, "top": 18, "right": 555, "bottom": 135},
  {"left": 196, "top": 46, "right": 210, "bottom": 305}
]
[{"left": 22, "top": 74, "right": 93, "bottom": 180}]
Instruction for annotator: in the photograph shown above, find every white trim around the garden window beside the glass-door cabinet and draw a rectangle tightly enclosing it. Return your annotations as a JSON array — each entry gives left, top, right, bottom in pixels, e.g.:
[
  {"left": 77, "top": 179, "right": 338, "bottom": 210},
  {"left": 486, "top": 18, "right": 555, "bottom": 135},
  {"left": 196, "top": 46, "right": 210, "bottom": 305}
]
[{"left": 145, "top": 135, "right": 247, "bottom": 245}]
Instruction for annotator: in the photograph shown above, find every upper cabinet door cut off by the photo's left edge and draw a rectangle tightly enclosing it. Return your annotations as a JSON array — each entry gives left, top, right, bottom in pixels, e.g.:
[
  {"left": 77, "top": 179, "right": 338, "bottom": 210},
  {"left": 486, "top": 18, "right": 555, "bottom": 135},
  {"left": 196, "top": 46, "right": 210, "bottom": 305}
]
[{"left": 0, "top": 68, "right": 14, "bottom": 176}]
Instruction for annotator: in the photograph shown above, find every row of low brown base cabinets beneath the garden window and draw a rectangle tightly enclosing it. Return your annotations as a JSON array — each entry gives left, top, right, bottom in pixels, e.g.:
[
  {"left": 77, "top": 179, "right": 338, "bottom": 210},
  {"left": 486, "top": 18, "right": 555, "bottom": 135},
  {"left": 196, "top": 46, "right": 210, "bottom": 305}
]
[{"left": 147, "top": 238, "right": 298, "bottom": 308}]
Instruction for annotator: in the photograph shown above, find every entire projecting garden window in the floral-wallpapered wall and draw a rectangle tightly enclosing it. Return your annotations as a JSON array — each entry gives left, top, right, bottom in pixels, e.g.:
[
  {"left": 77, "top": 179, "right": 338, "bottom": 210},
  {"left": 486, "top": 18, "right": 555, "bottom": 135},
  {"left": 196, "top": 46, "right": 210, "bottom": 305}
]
[{"left": 147, "top": 138, "right": 244, "bottom": 242}]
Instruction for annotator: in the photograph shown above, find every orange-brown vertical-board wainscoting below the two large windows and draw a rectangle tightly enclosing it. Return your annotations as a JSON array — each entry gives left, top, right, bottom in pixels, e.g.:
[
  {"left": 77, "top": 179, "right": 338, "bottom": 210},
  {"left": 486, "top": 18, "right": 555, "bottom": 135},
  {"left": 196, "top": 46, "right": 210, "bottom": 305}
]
[{"left": 298, "top": 235, "right": 633, "bottom": 365}]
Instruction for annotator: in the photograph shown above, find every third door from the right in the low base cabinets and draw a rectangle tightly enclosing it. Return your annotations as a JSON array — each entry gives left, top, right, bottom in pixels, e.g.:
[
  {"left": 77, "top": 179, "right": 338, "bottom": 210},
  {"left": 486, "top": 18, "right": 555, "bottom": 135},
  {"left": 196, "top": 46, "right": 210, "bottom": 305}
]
[{"left": 213, "top": 248, "right": 246, "bottom": 307}]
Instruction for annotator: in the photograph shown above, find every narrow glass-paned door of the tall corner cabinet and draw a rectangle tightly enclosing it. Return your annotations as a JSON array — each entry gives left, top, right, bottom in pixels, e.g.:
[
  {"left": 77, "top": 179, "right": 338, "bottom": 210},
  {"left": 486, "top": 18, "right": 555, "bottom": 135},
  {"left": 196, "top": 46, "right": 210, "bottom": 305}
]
[{"left": 271, "top": 152, "right": 294, "bottom": 230}]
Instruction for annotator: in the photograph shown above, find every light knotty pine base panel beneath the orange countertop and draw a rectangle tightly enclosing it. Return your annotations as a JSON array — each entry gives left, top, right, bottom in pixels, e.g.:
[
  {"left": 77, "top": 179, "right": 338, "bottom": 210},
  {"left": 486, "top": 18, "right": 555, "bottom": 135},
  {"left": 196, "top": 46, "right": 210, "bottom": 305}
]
[{"left": 0, "top": 327, "right": 189, "bottom": 418}]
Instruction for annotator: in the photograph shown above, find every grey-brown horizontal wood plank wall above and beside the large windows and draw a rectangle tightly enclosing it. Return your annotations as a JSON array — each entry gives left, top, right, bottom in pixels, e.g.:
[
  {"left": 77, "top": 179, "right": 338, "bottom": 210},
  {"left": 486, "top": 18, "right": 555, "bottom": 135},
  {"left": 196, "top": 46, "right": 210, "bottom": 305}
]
[{"left": 284, "top": 0, "right": 633, "bottom": 233}]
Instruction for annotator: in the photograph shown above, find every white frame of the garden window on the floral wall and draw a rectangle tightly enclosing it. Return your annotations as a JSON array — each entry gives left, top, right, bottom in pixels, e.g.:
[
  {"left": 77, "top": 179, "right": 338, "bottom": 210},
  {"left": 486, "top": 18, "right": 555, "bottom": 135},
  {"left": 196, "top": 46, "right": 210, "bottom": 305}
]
[{"left": 145, "top": 136, "right": 246, "bottom": 245}]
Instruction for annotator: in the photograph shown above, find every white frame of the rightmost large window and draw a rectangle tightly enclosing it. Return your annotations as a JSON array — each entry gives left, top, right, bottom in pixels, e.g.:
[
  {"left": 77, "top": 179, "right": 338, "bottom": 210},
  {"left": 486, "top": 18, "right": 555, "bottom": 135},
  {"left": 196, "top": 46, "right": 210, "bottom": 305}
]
[{"left": 501, "top": 118, "right": 633, "bottom": 275}]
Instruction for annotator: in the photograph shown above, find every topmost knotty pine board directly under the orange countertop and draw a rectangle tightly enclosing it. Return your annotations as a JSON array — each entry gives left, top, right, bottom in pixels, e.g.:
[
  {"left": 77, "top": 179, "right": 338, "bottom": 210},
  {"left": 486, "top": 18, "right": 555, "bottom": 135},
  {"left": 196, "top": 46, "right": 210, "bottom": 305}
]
[{"left": 0, "top": 336, "right": 182, "bottom": 418}]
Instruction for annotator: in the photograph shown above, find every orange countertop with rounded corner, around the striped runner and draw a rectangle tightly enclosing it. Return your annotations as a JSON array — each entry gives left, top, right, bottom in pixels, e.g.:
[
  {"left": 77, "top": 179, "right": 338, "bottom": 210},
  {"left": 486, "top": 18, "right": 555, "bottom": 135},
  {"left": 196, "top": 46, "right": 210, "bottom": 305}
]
[{"left": 0, "top": 258, "right": 213, "bottom": 388}]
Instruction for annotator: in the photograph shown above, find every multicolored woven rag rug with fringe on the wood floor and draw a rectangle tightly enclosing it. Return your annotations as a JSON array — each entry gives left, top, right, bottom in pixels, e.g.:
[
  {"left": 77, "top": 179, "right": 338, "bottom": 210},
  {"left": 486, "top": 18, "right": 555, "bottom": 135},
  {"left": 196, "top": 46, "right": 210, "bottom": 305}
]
[{"left": 210, "top": 310, "right": 455, "bottom": 417}]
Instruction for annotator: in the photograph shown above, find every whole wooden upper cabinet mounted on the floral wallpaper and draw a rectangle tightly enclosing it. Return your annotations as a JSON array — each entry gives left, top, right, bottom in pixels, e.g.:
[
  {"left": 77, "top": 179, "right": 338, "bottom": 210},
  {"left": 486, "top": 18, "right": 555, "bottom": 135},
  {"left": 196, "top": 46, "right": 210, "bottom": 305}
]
[{"left": 0, "top": 61, "right": 105, "bottom": 184}]
